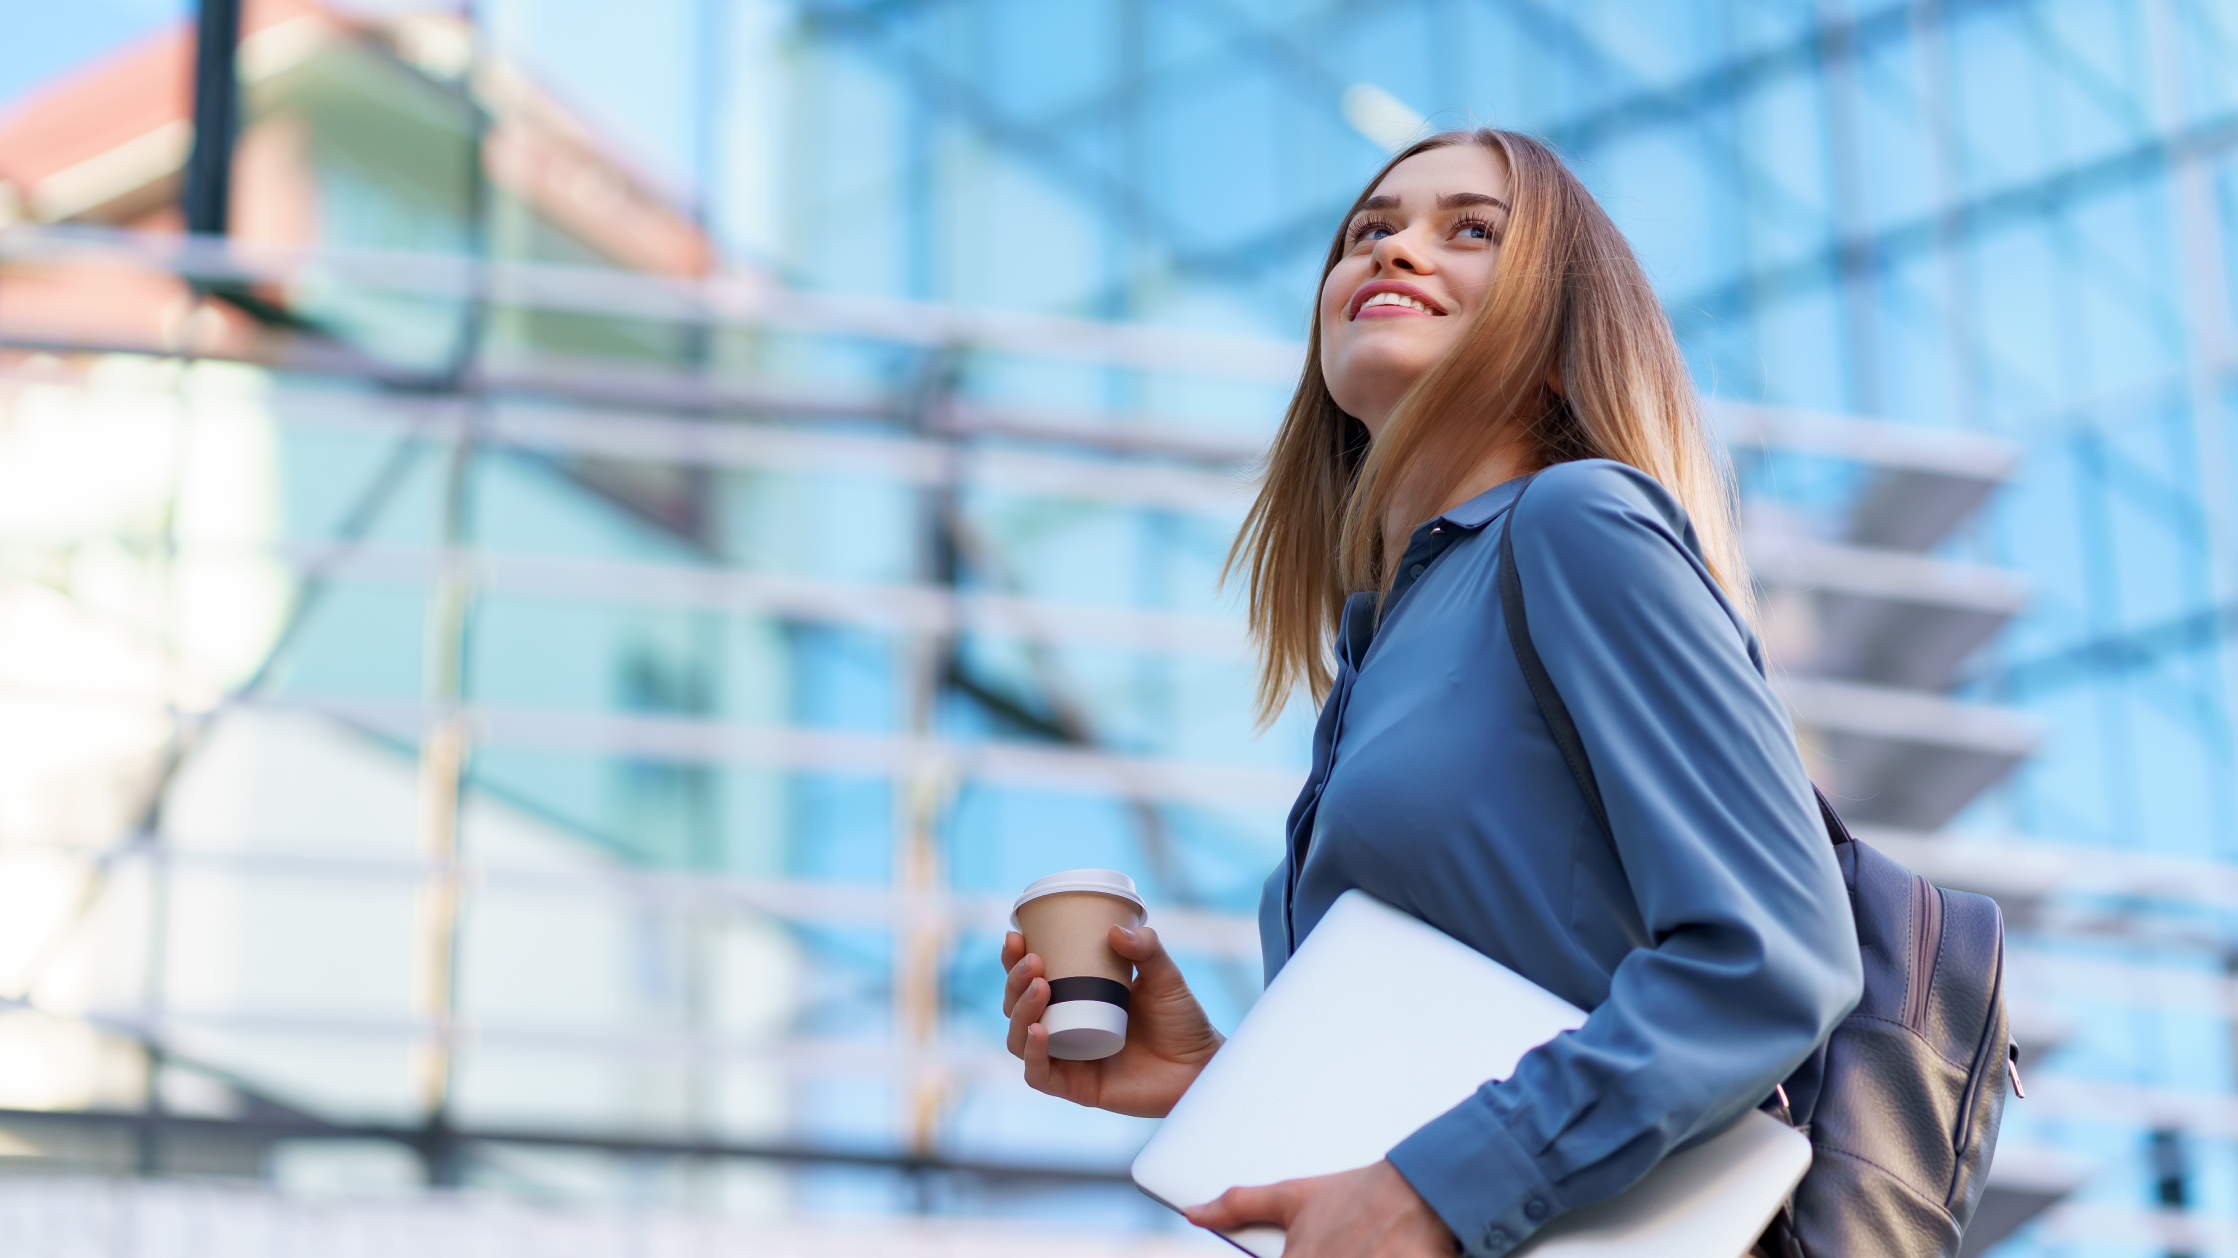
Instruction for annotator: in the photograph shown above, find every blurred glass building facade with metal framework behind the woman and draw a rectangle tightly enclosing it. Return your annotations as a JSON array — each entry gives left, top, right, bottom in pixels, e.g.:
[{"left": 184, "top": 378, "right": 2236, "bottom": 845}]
[{"left": 0, "top": 0, "right": 2238, "bottom": 1254}]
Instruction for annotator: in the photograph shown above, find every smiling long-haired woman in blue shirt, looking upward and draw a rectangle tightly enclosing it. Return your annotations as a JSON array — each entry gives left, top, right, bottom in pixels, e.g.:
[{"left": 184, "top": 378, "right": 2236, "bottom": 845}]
[{"left": 1003, "top": 130, "right": 1860, "bottom": 1258}]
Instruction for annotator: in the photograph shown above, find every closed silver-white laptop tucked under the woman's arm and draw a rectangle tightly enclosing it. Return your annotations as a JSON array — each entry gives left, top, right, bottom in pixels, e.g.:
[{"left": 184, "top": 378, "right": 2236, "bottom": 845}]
[{"left": 1135, "top": 891, "right": 1811, "bottom": 1258}]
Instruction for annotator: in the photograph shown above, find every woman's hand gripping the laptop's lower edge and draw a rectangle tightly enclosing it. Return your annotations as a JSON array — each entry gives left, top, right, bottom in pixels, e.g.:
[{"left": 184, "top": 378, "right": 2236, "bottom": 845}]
[{"left": 1182, "top": 1162, "right": 1459, "bottom": 1258}]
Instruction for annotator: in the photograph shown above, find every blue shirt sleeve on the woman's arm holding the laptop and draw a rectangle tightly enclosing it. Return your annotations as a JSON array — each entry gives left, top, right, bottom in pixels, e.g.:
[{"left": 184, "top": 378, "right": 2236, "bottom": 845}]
[{"left": 1390, "top": 459, "right": 1862, "bottom": 1258}]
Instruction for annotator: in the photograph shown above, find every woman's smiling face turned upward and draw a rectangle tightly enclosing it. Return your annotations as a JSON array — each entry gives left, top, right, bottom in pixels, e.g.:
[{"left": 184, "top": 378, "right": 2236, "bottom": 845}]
[{"left": 1320, "top": 143, "right": 1508, "bottom": 434}]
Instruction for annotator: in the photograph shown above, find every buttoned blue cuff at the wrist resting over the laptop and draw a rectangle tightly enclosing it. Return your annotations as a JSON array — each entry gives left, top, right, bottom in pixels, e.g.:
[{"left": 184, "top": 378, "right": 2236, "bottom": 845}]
[{"left": 1388, "top": 1097, "right": 1562, "bottom": 1258}]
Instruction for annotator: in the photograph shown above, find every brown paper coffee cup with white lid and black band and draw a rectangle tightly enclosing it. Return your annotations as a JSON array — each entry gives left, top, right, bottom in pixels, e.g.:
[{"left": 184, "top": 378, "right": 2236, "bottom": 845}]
[{"left": 1009, "top": 869, "right": 1150, "bottom": 1061}]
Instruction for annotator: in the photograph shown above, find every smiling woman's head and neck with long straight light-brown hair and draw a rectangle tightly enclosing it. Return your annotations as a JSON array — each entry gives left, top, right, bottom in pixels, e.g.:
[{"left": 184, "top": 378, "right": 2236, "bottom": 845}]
[{"left": 1233, "top": 130, "right": 1752, "bottom": 721}]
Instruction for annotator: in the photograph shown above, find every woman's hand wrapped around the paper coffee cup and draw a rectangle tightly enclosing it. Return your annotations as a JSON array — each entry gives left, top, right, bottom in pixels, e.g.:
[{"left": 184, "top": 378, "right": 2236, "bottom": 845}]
[{"left": 1003, "top": 927, "right": 1222, "bottom": 1119}]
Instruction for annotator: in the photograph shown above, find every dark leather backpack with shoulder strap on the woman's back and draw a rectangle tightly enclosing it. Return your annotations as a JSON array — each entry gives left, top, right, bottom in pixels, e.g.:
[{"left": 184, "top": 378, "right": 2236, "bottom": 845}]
[{"left": 1499, "top": 486, "right": 2021, "bottom": 1258}]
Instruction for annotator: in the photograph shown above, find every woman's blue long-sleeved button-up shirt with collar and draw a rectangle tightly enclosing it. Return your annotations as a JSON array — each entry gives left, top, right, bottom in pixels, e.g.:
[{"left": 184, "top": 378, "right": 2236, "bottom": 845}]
[{"left": 1260, "top": 459, "right": 1862, "bottom": 1258}]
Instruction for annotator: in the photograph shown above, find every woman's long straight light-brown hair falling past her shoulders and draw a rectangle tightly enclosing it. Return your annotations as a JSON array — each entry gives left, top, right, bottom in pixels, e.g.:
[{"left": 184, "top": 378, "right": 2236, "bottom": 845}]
[{"left": 1226, "top": 128, "right": 1752, "bottom": 725}]
